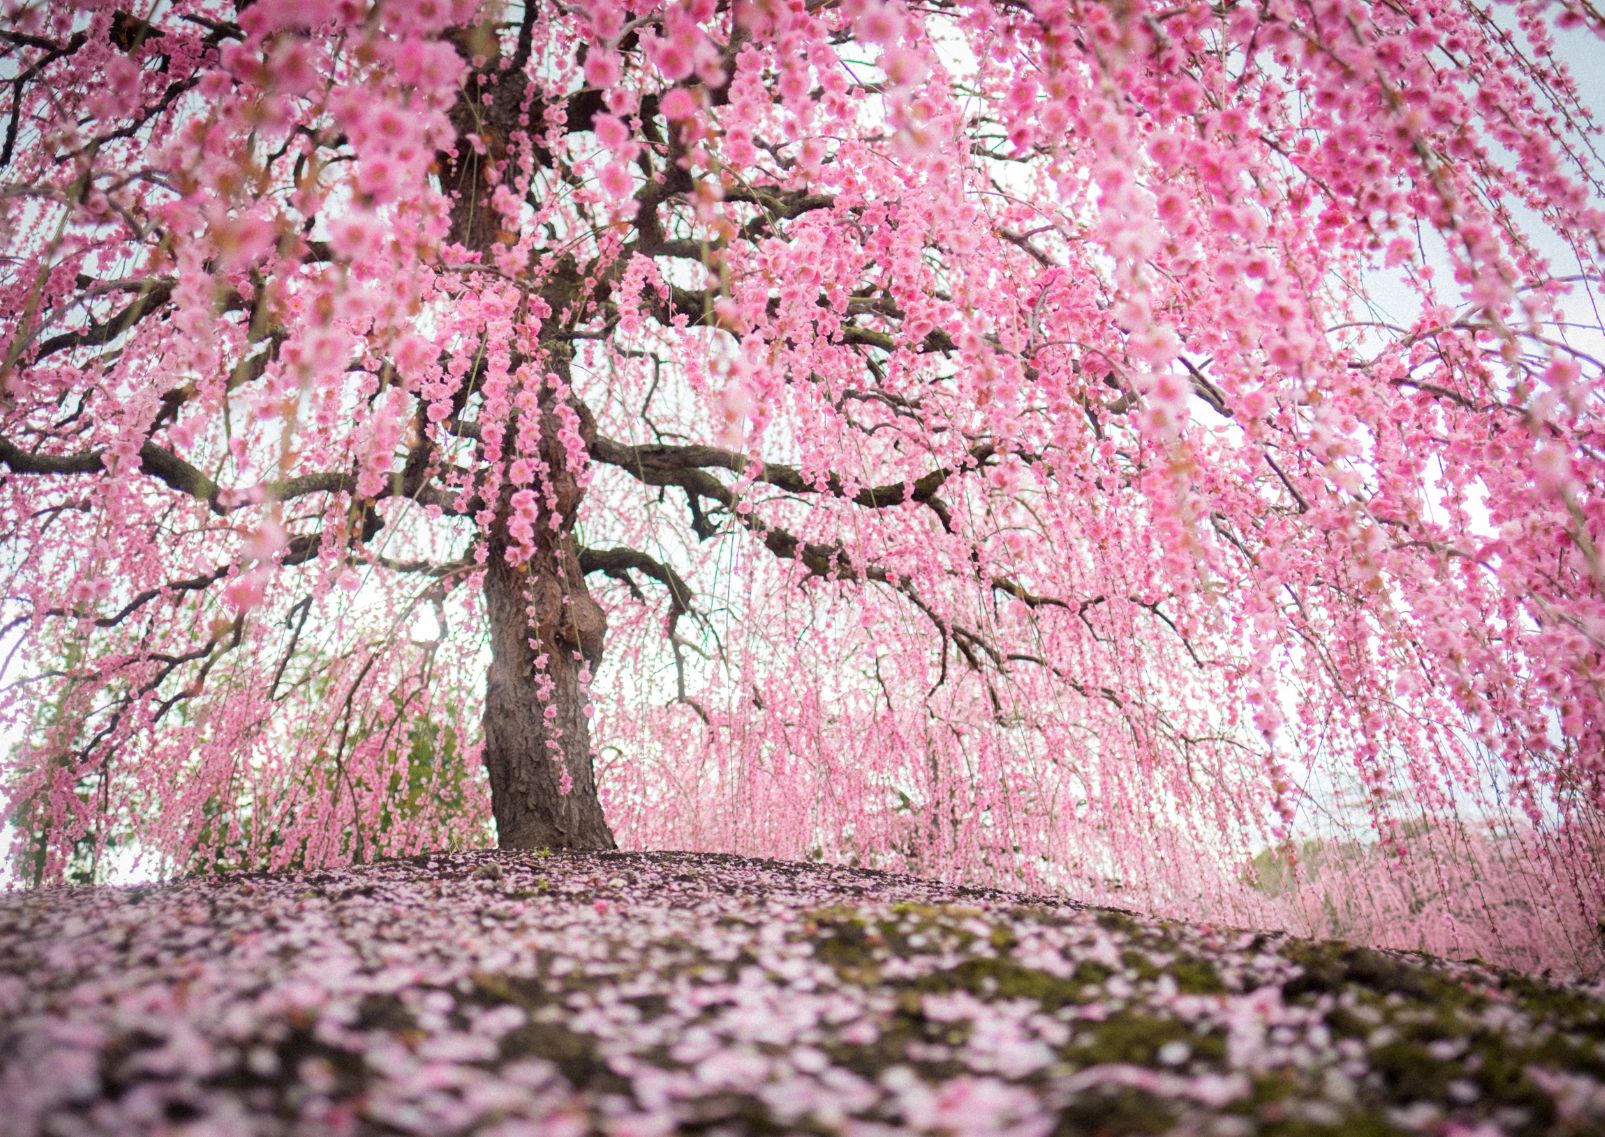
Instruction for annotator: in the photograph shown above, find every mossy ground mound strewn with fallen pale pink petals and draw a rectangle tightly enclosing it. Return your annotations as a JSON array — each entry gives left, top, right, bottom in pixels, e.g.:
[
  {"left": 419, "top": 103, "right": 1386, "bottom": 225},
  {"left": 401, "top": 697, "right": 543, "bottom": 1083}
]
[{"left": 0, "top": 853, "right": 1605, "bottom": 1137}]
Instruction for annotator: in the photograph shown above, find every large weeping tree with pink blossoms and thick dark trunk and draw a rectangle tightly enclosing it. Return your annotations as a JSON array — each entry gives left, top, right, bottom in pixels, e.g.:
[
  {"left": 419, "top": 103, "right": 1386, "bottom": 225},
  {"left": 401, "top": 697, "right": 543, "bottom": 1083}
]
[{"left": 0, "top": 0, "right": 1605, "bottom": 931}]
